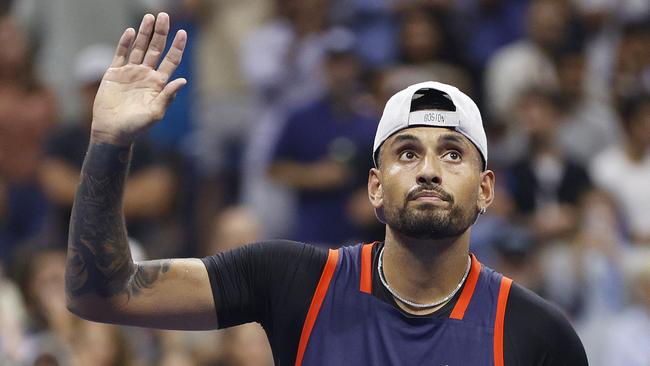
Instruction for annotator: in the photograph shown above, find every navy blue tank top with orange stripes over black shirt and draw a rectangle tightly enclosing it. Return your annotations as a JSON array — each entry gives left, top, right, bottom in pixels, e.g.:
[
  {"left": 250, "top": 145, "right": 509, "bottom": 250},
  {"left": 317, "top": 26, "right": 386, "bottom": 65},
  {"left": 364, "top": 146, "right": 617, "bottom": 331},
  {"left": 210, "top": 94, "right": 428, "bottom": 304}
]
[{"left": 296, "top": 243, "right": 512, "bottom": 366}]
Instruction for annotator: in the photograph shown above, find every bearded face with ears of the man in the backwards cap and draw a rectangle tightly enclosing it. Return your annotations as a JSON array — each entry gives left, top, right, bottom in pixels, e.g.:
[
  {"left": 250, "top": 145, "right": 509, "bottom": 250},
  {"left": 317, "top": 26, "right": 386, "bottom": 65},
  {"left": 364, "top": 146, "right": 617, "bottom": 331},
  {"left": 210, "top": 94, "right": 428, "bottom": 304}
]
[{"left": 368, "top": 127, "right": 494, "bottom": 239}]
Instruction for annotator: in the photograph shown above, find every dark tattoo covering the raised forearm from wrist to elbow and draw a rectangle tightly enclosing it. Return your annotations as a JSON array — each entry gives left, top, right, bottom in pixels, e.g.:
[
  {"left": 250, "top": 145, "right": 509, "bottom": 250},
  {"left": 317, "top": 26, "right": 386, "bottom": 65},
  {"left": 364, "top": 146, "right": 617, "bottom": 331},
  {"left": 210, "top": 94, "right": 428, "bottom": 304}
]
[{"left": 65, "top": 143, "right": 171, "bottom": 299}]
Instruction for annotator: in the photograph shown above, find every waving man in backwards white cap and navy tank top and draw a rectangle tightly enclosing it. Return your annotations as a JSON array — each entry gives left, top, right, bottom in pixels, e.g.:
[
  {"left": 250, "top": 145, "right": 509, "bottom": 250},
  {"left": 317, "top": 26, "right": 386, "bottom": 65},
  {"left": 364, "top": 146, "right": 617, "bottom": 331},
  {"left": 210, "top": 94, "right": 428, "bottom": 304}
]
[{"left": 66, "top": 13, "right": 587, "bottom": 365}]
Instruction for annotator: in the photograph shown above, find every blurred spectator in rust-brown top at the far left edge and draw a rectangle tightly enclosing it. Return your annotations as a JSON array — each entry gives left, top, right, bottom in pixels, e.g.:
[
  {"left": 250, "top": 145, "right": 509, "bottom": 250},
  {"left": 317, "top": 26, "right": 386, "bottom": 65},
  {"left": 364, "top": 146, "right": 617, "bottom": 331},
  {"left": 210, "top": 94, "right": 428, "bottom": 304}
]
[{"left": 0, "top": 16, "right": 56, "bottom": 264}]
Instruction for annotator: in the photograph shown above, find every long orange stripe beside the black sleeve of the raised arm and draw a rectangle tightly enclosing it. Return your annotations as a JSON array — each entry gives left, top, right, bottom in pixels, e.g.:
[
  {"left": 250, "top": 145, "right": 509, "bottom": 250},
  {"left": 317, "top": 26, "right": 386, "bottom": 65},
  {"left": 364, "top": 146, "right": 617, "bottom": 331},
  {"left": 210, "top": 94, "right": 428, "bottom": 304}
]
[{"left": 296, "top": 249, "right": 339, "bottom": 366}]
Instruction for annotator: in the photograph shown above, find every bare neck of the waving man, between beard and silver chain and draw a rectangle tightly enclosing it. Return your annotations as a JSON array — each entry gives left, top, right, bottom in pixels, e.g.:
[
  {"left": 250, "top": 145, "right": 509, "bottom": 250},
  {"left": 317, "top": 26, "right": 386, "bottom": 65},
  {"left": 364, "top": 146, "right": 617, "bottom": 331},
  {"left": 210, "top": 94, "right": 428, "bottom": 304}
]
[{"left": 383, "top": 226, "right": 470, "bottom": 312}]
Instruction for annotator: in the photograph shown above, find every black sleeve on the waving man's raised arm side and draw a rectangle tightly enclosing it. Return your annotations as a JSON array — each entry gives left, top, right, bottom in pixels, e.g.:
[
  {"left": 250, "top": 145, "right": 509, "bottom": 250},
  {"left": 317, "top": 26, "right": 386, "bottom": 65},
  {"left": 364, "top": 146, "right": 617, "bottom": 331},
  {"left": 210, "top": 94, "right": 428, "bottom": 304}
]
[{"left": 203, "top": 240, "right": 328, "bottom": 363}]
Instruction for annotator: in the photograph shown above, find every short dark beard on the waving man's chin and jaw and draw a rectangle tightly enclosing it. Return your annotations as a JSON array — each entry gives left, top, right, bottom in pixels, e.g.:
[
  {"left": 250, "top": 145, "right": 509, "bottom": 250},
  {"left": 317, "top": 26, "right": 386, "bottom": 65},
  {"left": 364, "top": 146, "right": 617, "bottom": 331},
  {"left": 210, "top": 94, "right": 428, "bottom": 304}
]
[{"left": 384, "top": 194, "right": 478, "bottom": 239}]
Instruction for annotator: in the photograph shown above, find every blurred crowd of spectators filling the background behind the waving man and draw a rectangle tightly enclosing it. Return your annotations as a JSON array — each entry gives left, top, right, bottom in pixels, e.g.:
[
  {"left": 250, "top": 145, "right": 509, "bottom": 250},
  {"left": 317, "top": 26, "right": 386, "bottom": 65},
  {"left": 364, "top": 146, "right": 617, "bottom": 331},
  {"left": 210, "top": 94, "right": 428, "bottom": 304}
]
[{"left": 0, "top": 0, "right": 650, "bottom": 366}]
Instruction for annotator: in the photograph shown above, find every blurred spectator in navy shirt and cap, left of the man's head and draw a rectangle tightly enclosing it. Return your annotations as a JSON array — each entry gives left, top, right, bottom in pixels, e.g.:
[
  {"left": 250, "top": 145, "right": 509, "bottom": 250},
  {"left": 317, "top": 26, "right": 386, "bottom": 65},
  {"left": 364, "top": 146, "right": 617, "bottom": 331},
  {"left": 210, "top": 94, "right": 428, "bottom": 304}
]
[{"left": 269, "top": 31, "right": 377, "bottom": 245}]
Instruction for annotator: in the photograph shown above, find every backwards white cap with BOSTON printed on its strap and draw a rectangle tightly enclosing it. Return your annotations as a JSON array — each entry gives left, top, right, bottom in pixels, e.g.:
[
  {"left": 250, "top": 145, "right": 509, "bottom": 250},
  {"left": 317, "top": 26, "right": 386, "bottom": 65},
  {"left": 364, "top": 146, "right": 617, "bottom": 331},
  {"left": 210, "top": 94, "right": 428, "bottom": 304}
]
[{"left": 372, "top": 81, "right": 488, "bottom": 168}]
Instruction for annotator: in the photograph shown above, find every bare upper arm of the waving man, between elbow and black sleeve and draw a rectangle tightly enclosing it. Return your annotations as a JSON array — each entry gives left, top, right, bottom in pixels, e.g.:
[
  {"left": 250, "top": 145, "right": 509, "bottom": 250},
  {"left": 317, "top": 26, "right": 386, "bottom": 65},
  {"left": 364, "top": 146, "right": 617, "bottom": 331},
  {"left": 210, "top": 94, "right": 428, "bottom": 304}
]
[{"left": 71, "top": 258, "right": 217, "bottom": 330}]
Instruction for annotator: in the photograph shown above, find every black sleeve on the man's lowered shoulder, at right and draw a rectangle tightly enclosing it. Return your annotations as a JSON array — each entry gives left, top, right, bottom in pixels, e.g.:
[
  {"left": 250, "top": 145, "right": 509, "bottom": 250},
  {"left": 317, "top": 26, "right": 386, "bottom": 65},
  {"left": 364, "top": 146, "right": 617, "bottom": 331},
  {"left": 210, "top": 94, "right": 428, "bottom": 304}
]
[{"left": 503, "top": 283, "right": 588, "bottom": 366}]
